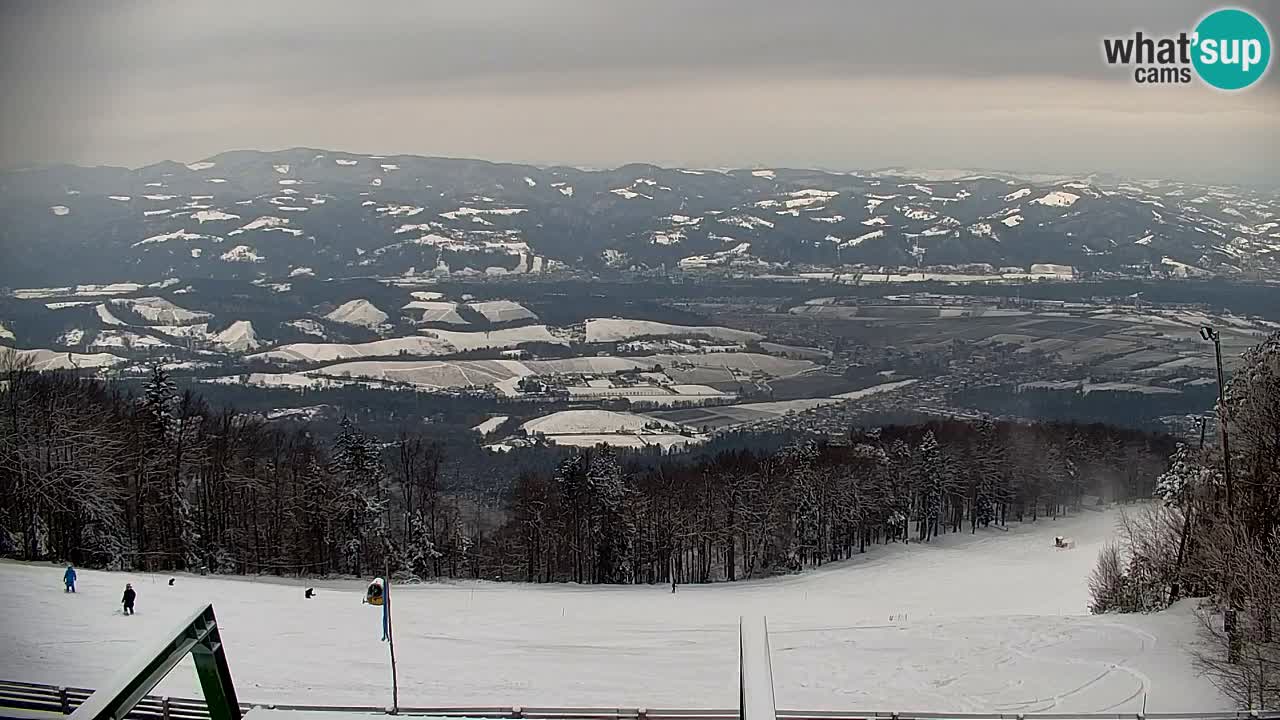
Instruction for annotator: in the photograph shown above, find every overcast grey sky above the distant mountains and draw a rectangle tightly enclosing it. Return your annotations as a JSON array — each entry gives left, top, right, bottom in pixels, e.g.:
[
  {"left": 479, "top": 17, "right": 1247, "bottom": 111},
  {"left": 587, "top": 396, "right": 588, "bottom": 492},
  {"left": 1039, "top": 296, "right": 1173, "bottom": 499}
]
[{"left": 0, "top": 0, "right": 1280, "bottom": 182}]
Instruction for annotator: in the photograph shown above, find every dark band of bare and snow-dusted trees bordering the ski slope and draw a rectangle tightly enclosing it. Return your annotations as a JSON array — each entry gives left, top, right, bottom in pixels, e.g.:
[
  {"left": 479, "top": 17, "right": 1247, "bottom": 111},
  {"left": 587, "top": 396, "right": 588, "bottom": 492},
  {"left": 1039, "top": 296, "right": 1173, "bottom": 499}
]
[{"left": 0, "top": 345, "right": 1172, "bottom": 583}]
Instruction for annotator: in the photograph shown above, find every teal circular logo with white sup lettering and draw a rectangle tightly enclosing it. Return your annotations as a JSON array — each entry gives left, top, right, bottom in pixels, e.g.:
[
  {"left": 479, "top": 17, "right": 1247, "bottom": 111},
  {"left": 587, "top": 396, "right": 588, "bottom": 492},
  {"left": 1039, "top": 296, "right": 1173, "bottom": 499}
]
[{"left": 1192, "top": 8, "right": 1271, "bottom": 90}]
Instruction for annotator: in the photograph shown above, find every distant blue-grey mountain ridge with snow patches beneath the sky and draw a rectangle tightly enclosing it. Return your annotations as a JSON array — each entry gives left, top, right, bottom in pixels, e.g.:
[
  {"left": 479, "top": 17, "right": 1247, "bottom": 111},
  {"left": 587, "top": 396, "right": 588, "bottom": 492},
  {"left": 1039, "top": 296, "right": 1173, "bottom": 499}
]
[{"left": 0, "top": 149, "right": 1280, "bottom": 287}]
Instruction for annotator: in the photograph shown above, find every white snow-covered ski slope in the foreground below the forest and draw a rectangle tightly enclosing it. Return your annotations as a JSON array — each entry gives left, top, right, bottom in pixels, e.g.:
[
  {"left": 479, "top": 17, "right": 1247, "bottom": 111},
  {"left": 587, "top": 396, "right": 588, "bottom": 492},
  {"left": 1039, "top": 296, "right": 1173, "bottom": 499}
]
[{"left": 0, "top": 511, "right": 1229, "bottom": 714}]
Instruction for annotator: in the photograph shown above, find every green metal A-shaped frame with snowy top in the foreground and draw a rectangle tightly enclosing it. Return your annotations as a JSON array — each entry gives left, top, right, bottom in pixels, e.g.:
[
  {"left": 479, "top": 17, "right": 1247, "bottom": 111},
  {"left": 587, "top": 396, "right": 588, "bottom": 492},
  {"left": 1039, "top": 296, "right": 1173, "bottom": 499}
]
[{"left": 70, "top": 605, "right": 241, "bottom": 720}]
